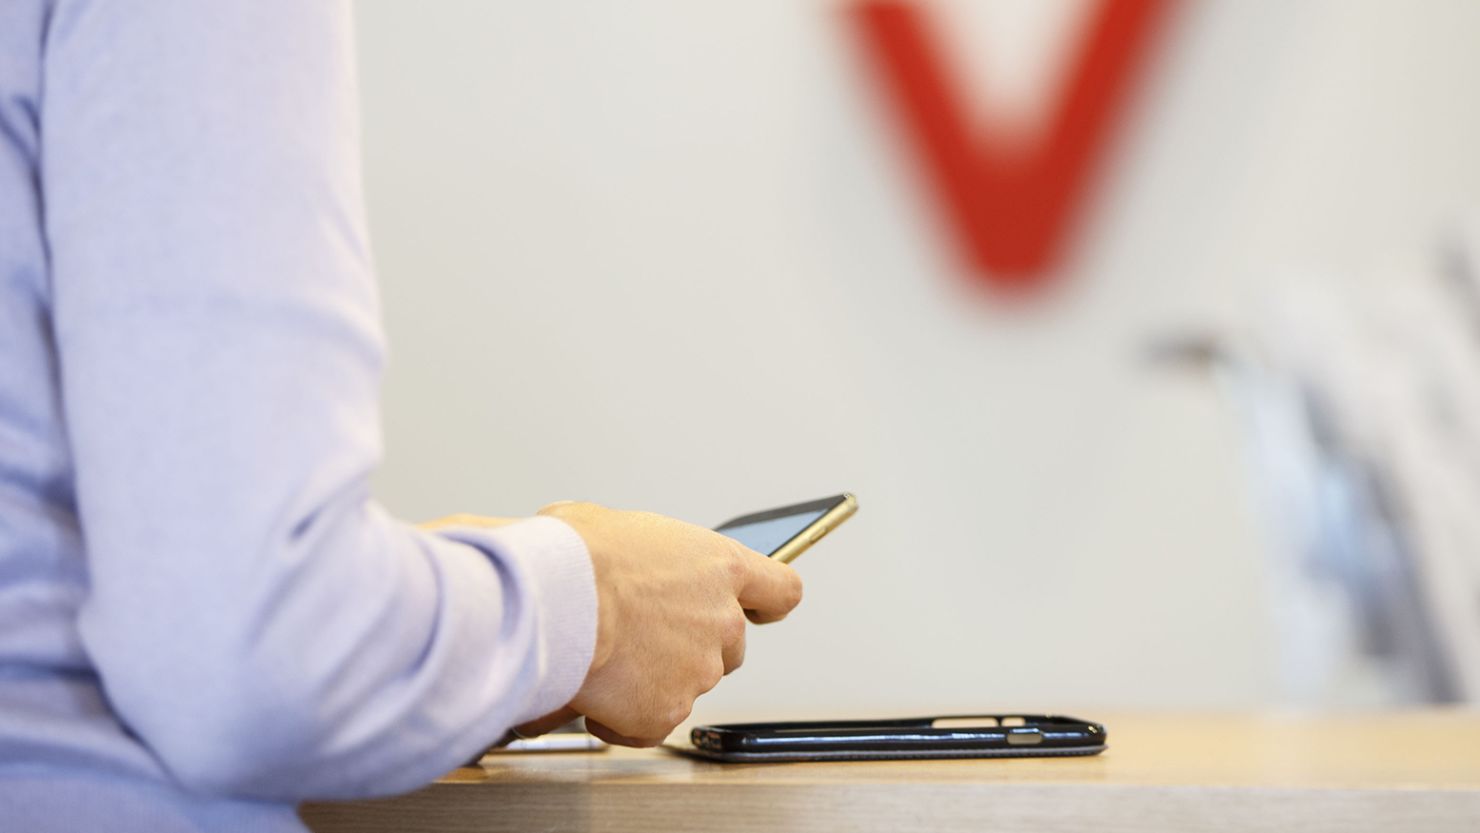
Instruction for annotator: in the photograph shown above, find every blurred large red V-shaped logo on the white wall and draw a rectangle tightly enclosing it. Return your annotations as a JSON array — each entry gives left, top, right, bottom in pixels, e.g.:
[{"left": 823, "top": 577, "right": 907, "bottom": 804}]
[{"left": 852, "top": 0, "right": 1172, "bottom": 290}]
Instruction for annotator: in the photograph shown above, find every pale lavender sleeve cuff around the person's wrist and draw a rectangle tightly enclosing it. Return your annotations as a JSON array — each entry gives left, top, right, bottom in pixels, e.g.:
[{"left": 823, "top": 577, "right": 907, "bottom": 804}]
[{"left": 437, "top": 516, "right": 596, "bottom": 725}]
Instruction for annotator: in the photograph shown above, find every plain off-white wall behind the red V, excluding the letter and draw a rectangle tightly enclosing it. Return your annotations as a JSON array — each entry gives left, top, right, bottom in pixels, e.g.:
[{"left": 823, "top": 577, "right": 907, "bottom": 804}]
[{"left": 357, "top": 0, "right": 1480, "bottom": 718}]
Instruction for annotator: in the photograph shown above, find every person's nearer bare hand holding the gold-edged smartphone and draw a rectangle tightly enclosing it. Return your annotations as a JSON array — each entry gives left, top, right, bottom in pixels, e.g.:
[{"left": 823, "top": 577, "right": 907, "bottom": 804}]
[{"left": 531, "top": 503, "right": 802, "bottom": 746}]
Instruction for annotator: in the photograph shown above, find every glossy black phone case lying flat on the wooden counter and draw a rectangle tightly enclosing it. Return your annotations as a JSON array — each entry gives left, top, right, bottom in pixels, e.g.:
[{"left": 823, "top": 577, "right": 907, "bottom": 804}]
[{"left": 685, "top": 715, "right": 1107, "bottom": 762}]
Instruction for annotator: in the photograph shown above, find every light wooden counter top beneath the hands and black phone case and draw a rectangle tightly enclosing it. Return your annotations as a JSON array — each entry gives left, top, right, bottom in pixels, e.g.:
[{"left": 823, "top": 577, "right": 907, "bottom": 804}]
[{"left": 303, "top": 710, "right": 1480, "bottom": 833}]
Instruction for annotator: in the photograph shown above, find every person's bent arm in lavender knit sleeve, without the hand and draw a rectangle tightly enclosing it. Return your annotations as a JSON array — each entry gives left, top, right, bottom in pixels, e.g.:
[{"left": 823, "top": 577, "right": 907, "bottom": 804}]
[{"left": 40, "top": 0, "right": 596, "bottom": 800}]
